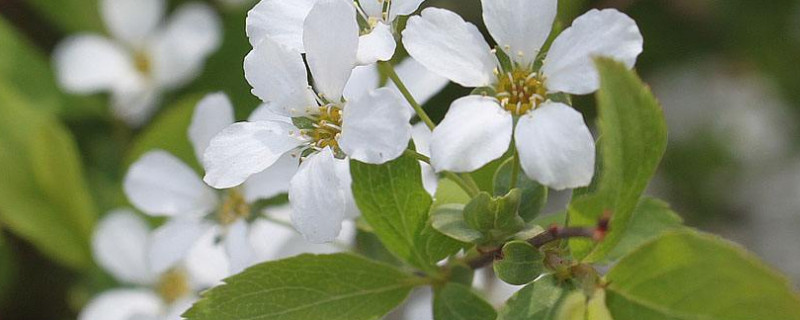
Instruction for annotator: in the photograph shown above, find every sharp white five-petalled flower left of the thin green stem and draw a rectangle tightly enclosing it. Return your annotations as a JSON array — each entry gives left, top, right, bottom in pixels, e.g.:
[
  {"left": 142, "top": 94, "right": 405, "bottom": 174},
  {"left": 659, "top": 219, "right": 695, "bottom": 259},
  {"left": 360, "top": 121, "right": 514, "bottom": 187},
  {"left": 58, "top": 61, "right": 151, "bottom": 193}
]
[{"left": 204, "top": 0, "right": 411, "bottom": 242}]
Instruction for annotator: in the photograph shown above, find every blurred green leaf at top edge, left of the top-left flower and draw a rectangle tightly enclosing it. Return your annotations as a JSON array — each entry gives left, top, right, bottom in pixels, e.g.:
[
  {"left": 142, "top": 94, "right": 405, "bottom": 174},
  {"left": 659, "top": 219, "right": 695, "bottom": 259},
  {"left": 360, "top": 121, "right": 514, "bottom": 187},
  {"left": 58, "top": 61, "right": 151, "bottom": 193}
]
[{"left": 26, "top": 0, "right": 104, "bottom": 33}]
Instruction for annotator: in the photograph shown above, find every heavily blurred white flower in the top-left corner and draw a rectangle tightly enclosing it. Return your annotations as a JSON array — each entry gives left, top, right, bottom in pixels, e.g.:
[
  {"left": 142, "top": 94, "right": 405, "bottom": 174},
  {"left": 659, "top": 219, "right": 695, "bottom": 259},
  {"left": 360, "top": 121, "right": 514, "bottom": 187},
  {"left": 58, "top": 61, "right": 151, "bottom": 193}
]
[{"left": 53, "top": 0, "right": 221, "bottom": 125}]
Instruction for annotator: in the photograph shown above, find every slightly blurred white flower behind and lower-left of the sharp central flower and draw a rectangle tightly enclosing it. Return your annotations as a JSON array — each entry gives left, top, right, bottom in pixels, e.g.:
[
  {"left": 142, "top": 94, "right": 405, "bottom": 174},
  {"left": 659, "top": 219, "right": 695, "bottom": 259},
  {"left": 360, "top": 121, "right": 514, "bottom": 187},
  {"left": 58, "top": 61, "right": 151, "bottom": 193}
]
[{"left": 123, "top": 93, "right": 298, "bottom": 273}]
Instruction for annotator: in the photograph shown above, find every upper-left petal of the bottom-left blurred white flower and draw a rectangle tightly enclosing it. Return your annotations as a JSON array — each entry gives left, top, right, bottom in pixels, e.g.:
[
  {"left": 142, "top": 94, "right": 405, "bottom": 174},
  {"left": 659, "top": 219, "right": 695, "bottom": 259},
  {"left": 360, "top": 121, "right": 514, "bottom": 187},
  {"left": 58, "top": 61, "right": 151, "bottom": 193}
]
[{"left": 92, "top": 210, "right": 155, "bottom": 285}]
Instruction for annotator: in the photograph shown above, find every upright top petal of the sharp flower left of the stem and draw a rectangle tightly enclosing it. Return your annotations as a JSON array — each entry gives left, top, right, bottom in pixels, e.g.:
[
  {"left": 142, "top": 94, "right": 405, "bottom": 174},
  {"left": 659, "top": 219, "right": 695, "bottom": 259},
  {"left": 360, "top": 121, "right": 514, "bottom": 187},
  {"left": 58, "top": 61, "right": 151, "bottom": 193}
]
[{"left": 303, "top": 0, "right": 358, "bottom": 102}]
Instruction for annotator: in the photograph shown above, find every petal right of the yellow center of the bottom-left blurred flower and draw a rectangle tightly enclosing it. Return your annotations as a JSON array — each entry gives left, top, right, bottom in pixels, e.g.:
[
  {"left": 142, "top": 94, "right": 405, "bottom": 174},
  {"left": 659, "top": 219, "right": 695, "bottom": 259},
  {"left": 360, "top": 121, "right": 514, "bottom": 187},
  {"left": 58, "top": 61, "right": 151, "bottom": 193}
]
[{"left": 184, "top": 226, "right": 231, "bottom": 290}]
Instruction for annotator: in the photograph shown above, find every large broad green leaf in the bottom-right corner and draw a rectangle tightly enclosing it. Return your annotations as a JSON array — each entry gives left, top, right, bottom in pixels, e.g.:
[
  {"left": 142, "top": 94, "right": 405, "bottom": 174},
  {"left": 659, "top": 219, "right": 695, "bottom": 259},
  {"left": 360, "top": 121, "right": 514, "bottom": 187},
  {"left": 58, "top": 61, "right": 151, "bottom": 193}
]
[{"left": 606, "top": 231, "right": 800, "bottom": 320}]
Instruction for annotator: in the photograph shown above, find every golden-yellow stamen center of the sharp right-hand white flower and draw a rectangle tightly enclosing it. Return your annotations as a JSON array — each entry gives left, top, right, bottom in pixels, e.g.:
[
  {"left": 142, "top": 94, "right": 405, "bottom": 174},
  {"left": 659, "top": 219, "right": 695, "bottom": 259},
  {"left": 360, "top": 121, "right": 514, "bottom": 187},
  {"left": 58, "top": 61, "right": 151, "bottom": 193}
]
[{"left": 495, "top": 69, "right": 547, "bottom": 116}]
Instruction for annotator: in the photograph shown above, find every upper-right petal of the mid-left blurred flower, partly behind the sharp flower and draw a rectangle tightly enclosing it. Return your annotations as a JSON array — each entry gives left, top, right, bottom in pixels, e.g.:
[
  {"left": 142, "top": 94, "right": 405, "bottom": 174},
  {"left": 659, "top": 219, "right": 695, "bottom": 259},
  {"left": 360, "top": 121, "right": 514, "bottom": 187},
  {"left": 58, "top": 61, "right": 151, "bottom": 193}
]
[{"left": 244, "top": 152, "right": 300, "bottom": 203}]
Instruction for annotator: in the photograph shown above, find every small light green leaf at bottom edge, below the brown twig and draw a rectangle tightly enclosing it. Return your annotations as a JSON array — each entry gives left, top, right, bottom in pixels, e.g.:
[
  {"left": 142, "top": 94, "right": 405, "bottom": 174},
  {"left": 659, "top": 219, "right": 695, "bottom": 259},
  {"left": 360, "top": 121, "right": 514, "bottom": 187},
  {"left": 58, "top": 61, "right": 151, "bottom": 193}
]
[{"left": 497, "top": 275, "right": 577, "bottom": 320}]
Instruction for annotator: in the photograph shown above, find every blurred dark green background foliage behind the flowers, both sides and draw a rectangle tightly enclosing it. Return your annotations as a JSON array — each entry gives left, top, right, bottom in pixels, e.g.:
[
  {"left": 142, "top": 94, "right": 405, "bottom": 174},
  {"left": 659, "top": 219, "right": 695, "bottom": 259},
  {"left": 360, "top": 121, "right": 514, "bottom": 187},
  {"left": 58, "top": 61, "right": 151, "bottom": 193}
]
[{"left": 0, "top": 0, "right": 800, "bottom": 320}]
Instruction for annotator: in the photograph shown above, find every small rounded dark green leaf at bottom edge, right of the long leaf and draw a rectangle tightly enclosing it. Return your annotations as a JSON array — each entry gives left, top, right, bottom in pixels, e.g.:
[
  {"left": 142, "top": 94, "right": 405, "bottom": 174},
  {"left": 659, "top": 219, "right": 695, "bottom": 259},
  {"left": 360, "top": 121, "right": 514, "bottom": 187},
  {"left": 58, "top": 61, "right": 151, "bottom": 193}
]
[{"left": 433, "top": 283, "right": 497, "bottom": 320}]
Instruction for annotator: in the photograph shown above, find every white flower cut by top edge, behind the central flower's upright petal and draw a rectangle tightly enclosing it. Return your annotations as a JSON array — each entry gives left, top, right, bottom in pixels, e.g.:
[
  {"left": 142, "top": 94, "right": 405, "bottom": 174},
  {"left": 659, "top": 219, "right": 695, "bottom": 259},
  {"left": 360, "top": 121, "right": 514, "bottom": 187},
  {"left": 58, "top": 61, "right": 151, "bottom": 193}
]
[{"left": 247, "top": 0, "right": 424, "bottom": 65}]
